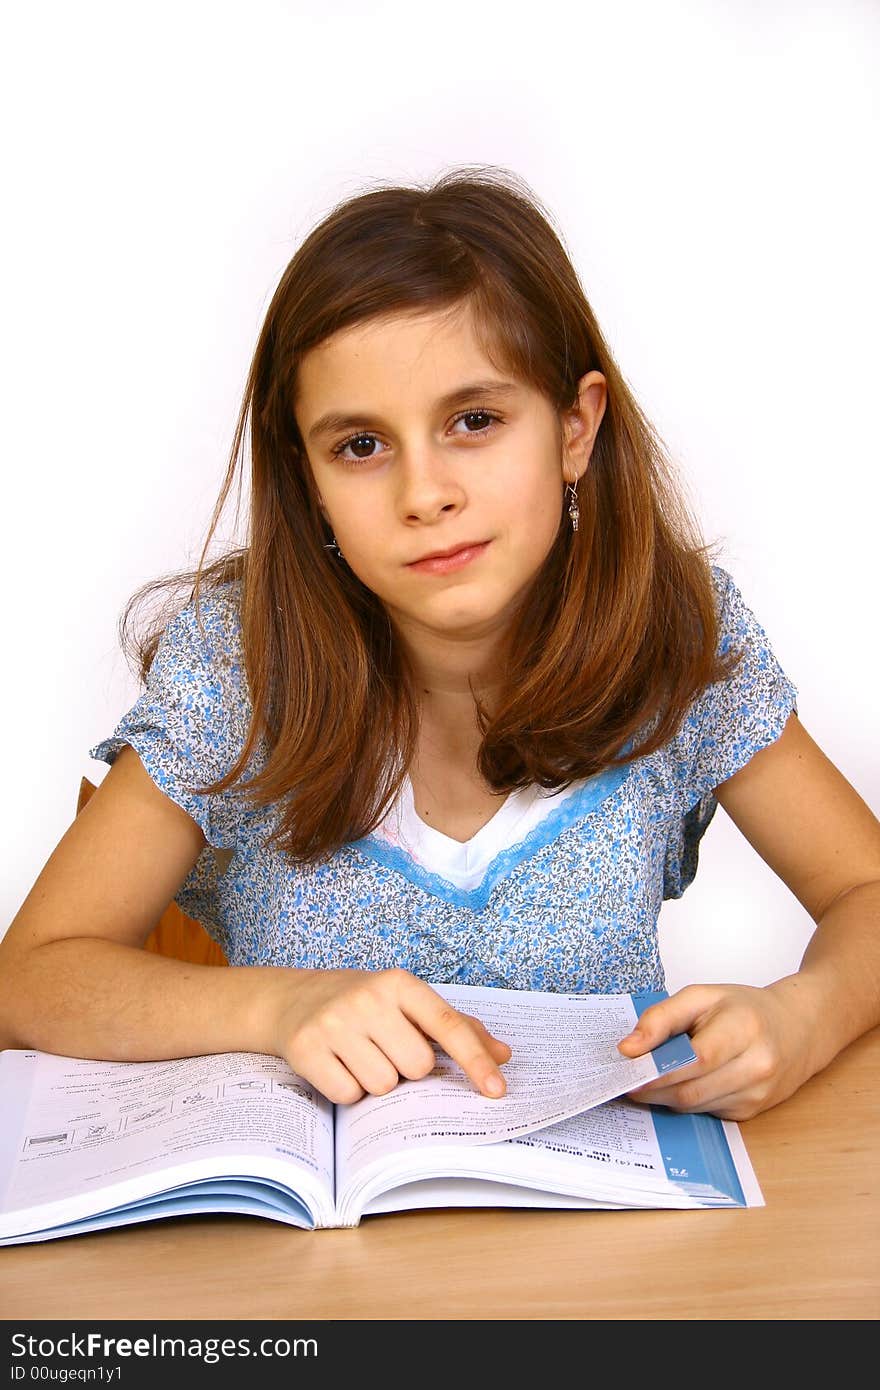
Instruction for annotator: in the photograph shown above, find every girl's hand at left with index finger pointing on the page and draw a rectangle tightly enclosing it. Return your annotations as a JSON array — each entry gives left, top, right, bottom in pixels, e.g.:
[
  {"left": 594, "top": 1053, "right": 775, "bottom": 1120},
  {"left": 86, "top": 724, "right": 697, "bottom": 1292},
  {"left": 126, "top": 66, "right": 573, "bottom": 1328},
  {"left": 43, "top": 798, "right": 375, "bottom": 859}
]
[{"left": 268, "top": 969, "right": 510, "bottom": 1105}]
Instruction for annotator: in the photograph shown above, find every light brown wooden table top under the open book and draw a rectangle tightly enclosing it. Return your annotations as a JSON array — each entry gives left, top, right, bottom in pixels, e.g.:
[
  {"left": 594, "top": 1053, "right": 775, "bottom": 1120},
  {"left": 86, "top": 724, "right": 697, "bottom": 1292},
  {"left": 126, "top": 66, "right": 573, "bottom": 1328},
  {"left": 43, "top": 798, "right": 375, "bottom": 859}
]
[{"left": 0, "top": 1029, "right": 880, "bottom": 1321}]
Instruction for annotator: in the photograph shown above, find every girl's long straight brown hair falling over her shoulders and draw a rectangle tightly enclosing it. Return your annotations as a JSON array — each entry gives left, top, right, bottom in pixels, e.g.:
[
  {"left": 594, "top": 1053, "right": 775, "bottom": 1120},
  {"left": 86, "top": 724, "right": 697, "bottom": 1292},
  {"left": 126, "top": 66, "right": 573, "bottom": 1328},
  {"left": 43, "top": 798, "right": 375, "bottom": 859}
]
[{"left": 120, "top": 165, "right": 738, "bottom": 863}]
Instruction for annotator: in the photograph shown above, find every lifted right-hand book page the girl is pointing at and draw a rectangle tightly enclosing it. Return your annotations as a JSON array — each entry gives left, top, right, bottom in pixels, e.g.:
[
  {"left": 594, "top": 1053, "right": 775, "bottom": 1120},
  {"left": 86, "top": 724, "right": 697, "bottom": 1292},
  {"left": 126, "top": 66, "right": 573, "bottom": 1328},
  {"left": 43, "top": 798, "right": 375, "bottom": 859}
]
[{"left": 336, "top": 984, "right": 694, "bottom": 1191}]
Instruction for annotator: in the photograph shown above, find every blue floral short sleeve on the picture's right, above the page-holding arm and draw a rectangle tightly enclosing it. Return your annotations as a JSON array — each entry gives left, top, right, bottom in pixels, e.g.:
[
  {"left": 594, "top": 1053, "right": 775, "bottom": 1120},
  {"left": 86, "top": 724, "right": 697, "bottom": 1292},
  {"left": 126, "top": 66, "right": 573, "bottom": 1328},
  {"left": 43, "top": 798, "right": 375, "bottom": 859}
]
[{"left": 663, "top": 564, "right": 798, "bottom": 898}]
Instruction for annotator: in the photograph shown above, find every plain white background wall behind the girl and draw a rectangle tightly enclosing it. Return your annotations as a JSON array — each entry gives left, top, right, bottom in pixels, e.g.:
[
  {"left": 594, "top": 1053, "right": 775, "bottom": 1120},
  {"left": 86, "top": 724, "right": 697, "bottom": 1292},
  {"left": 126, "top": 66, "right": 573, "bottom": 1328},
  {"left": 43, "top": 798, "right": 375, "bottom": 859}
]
[{"left": 0, "top": 0, "right": 880, "bottom": 987}]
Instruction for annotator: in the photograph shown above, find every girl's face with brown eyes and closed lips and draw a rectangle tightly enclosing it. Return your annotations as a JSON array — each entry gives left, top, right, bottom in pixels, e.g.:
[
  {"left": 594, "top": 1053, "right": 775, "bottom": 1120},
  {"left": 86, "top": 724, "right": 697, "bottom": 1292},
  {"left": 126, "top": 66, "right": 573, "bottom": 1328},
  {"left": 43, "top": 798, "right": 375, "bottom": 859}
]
[{"left": 295, "top": 306, "right": 605, "bottom": 667}]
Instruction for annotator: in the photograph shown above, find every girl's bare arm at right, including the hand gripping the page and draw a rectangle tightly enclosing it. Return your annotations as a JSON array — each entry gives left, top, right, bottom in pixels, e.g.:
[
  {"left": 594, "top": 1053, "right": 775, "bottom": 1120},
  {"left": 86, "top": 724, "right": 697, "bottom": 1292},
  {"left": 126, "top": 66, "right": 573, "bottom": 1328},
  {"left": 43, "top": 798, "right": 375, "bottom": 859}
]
[{"left": 620, "top": 714, "right": 880, "bottom": 1120}]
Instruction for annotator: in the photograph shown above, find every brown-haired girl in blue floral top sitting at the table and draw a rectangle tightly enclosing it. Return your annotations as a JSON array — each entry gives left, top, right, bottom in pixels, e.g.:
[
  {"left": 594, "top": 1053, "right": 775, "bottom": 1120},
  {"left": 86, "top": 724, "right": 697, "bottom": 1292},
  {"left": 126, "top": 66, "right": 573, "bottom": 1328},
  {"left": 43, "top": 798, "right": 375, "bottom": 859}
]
[{"left": 0, "top": 170, "right": 880, "bottom": 1119}]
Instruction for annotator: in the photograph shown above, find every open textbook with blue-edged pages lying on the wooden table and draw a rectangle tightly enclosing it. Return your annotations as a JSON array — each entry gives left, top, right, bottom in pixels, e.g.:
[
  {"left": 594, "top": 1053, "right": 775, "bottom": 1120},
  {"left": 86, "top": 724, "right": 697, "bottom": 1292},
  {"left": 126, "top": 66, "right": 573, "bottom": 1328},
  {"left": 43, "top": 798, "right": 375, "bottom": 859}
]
[{"left": 0, "top": 984, "right": 763, "bottom": 1245}]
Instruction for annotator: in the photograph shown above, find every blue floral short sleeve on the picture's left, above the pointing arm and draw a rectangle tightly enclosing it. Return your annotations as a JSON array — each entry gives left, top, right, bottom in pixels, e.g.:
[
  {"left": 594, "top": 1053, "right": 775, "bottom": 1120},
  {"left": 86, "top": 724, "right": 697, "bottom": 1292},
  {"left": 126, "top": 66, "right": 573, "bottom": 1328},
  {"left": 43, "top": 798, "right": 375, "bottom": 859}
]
[{"left": 89, "top": 585, "right": 247, "bottom": 849}]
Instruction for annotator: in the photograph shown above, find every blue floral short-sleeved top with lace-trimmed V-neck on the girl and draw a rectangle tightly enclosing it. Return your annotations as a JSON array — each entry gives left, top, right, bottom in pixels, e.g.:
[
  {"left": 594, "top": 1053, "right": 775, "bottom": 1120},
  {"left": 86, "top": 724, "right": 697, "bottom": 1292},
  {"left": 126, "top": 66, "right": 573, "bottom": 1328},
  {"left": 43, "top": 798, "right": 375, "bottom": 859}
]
[{"left": 90, "top": 566, "right": 797, "bottom": 994}]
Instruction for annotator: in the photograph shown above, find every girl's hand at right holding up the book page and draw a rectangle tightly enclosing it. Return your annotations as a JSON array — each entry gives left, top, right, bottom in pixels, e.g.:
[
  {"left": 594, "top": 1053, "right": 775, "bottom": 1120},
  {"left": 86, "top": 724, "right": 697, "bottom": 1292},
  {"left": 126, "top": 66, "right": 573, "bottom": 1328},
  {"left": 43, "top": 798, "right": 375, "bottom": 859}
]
[{"left": 617, "top": 976, "right": 819, "bottom": 1120}]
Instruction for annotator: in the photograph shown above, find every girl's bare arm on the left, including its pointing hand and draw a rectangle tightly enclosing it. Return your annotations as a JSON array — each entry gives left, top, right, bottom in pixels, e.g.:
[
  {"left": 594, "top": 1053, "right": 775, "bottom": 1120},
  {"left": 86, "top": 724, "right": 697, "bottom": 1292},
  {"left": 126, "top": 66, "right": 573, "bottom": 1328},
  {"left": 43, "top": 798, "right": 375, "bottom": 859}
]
[{"left": 0, "top": 745, "right": 510, "bottom": 1102}]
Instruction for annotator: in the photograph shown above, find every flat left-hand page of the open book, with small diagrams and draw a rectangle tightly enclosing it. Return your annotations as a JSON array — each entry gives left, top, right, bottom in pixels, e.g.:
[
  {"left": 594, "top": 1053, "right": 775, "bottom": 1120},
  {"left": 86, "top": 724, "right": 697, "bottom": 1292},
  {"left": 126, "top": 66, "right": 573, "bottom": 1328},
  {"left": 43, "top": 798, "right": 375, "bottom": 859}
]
[{"left": 0, "top": 1051, "right": 334, "bottom": 1213}]
